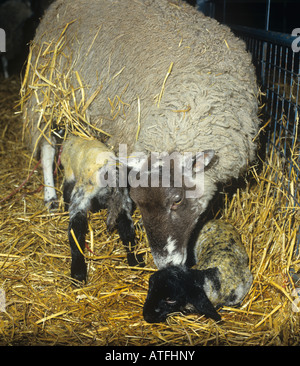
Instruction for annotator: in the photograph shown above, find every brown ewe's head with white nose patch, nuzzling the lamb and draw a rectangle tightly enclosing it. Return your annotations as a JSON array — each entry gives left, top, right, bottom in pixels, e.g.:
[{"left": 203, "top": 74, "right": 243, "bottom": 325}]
[{"left": 122, "top": 150, "right": 215, "bottom": 269}]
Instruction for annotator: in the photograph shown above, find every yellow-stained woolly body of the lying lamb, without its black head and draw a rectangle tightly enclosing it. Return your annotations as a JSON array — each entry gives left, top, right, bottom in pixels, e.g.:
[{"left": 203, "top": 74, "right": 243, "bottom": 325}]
[{"left": 194, "top": 220, "right": 253, "bottom": 305}]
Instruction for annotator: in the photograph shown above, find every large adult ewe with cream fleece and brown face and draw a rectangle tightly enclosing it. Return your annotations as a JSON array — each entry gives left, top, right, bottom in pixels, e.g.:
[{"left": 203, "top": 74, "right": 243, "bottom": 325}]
[{"left": 24, "top": 0, "right": 259, "bottom": 276}]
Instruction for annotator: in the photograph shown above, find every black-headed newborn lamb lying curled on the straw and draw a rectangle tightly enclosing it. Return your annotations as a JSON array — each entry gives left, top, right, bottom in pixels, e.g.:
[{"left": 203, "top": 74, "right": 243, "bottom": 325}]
[{"left": 143, "top": 220, "right": 253, "bottom": 323}]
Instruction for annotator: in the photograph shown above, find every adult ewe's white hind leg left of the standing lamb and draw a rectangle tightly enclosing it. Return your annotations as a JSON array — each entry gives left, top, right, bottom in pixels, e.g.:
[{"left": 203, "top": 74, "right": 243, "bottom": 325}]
[{"left": 41, "top": 140, "right": 57, "bottom": 208}]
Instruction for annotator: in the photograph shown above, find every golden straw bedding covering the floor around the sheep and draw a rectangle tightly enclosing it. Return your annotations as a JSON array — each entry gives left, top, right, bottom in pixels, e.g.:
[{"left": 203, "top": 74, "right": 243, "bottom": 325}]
[{"left": 0, "top": 78, "right": 300, "bottom": 345}]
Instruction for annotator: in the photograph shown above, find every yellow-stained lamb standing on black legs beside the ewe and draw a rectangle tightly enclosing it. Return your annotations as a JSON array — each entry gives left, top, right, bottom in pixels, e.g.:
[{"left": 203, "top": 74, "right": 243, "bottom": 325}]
[{"left": 61, "top": 136, "right": 141, "bottom": 282}]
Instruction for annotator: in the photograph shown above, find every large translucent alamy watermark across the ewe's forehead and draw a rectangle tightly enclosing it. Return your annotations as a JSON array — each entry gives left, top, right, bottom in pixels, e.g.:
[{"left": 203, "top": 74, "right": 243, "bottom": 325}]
[{"left": 96, "top": 144, "right": 210, "bottom": 198}]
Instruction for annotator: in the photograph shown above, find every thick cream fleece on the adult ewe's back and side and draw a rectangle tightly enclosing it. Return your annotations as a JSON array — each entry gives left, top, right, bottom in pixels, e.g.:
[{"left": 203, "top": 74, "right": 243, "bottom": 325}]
[{"left": 26, "top": 0, "right": 259, "bottom": 181}]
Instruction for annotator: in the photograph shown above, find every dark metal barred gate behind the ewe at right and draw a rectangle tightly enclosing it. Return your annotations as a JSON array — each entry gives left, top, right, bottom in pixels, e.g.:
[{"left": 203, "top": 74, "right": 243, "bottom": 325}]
[{"left": 232, "top": 26, "right": 300, "bottom": 207}]
